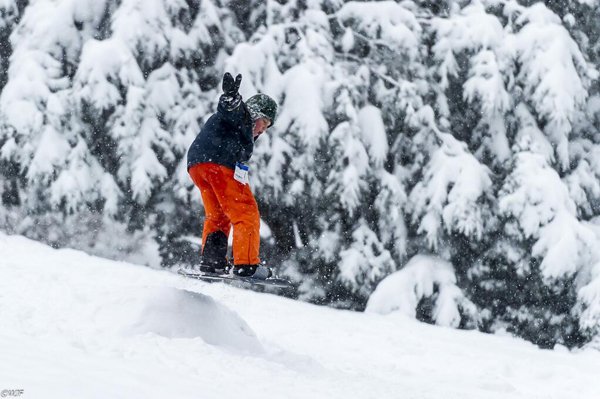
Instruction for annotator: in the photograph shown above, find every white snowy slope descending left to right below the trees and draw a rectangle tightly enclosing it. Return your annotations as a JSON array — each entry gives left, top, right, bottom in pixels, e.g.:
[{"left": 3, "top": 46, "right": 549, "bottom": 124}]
[{"left": 0, "top": 234, "right": 600, "bottom": 399}]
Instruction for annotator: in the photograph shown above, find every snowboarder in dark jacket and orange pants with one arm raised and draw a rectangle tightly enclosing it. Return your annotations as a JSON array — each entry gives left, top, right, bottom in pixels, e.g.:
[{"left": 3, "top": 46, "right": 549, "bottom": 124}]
[{"left": 187, "top": 73, "right": 277, "bottom": 279}]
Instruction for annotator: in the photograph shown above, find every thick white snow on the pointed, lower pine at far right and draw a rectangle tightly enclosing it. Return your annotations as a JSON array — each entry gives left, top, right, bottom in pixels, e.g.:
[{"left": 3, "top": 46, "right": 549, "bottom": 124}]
[{"left": 498, "top": 135, "right": 595, "bottom": 279}]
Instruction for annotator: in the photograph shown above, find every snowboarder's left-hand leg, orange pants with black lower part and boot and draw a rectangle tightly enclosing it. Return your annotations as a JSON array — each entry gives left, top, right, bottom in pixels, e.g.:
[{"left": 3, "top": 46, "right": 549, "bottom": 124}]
[{"left": 190, "top": 164, "right": 231, "bottom": 270}]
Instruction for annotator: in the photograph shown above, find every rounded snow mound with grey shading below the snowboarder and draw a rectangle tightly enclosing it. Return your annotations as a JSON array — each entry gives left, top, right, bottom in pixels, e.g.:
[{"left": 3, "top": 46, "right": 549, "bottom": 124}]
[{"left": 96, "top": 287, "right": 263, "bottom": 353}]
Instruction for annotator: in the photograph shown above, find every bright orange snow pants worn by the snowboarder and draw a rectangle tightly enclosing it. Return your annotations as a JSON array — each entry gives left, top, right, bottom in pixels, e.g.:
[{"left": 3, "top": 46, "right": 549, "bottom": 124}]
[{"left": 189, "top": 163, "right": 260, "bottom": 265}]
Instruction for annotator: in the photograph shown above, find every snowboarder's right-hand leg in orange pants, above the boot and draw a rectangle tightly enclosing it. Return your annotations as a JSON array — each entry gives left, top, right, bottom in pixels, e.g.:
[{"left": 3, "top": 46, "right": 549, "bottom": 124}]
[{"left": 202, "top": 164, "right": 260, "bottom": 265}]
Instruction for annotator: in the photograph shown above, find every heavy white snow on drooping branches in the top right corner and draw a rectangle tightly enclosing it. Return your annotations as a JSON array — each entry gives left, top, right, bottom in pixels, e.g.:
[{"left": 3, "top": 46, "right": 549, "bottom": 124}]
[{"left": 507, "top": 3, "right": 598, "bottom": 170}]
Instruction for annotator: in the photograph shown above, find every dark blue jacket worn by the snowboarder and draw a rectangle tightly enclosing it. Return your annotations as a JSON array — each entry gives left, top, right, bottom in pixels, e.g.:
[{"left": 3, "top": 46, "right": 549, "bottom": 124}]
[{"left": 187, "top": 95, "right": 254, "bottom": 170}]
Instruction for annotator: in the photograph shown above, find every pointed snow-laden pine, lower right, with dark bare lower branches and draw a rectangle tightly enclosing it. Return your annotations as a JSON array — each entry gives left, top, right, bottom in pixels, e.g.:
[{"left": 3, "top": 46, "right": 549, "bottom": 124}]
[{"left": 471, "top": 126, "right": 595, "bottom": 347}]
